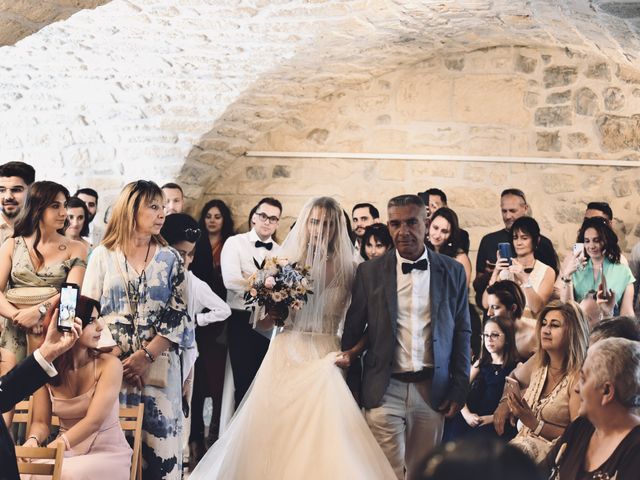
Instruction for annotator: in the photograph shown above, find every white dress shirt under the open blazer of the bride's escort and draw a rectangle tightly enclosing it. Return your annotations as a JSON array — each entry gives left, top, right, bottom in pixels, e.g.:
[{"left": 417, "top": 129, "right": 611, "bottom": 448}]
[{"left": 393, "top": 247, "right": 433, "bottom": 373}]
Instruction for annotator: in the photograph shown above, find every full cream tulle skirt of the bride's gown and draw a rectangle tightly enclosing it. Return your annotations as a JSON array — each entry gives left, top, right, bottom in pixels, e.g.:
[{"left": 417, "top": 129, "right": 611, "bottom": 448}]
[{"left": 189, "top": 331, "right": 395, "bottom": 480}]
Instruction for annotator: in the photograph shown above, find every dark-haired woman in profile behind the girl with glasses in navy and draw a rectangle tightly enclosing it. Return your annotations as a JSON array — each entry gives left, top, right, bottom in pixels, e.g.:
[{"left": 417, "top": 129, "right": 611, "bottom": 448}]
[{"left": 487, "top": 280, "right": 538, "bottom": 360}]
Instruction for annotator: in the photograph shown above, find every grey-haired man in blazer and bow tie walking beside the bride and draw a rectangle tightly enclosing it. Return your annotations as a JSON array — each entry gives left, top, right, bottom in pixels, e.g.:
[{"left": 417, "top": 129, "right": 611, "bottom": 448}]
[{"left": 342, "top": 195, "right": 471, "bottom": 480}]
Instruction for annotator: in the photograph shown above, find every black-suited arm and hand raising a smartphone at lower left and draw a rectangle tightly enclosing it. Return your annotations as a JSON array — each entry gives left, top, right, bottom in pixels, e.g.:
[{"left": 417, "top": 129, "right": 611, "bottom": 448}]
[{"left": 0, "top": 317, "right": 82, "bottom": 480}]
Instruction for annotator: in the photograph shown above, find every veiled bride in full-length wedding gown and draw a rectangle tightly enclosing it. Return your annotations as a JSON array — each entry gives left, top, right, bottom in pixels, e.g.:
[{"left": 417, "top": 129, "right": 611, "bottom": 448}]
[{"left": 189, "top": 197, "right": 395, "bottom": 480}]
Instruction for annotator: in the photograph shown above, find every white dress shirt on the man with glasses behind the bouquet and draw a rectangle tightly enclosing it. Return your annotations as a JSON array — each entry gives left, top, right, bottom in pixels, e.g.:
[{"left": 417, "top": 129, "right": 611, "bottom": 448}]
[{"left": 220, "top": 229, "right": 278, "bottom": 310}]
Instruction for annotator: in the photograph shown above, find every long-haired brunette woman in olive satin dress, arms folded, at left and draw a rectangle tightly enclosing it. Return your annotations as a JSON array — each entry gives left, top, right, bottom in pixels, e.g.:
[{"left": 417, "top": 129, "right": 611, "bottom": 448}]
[{"left": 0, "top": 181, "right": 87, "bottom": 361}]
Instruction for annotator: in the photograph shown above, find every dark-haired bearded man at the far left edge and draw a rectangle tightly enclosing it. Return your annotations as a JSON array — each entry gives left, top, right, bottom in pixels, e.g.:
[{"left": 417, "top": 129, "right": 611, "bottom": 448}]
[{"left": 0, "top": 162, "right": 36, "bottom": 245}]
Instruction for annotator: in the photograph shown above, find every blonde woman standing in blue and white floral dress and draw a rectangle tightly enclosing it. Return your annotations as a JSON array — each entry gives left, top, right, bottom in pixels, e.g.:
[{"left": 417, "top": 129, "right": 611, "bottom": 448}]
[{"left": 82, "top": 180, "right": 194, "bottom": 479}]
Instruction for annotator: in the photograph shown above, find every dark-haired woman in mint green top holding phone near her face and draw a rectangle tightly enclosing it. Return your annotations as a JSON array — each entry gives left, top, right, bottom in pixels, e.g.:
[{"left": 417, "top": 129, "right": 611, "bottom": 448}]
[{"left": 560, "top": 217, "right": 634, "bottom": 316}]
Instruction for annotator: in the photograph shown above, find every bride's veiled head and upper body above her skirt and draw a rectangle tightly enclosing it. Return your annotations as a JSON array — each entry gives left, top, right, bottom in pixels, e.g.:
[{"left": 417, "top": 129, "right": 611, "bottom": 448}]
[{"left": 277, "top": 197, "right": 355, "bottom": 334}]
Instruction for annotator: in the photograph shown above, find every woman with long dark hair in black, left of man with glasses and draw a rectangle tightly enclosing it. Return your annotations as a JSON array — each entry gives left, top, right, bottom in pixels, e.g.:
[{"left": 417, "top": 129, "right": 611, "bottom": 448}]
[{"left": 189, "top": 199, "right": 234, "bottom": 469}]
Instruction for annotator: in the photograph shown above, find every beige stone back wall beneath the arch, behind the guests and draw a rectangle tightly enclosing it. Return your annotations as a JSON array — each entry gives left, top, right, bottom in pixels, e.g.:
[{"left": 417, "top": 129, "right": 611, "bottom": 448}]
[{"left": 197, "top": 47, "right": 640, "bottom": 262}]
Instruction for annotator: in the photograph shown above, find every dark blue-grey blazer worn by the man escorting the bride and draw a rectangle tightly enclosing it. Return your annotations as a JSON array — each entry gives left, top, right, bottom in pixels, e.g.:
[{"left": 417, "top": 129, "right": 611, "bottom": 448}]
[{"left": 342, "top": 249, "right": 471, "bottom": 409}]
